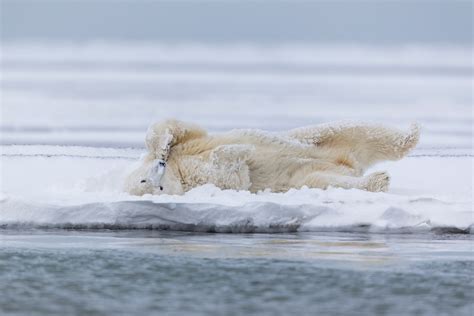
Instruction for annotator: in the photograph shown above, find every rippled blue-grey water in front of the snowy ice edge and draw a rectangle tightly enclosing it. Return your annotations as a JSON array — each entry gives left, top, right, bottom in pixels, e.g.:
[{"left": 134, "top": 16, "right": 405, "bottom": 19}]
[{"left": 0, "top": 230, "right": 474, "bottom": 315}]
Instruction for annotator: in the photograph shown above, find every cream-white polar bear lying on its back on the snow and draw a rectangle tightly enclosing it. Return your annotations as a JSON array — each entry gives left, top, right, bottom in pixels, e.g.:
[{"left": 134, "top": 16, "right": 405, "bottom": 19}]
[{"left": 125, "top": 120, "right": 420, "bottom": 195}]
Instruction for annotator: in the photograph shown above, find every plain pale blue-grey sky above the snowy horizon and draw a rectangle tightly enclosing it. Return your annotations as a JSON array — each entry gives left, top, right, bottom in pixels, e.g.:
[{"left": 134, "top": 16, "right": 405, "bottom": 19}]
[{"left": 0, "top": 0, "right": 473, "bottom": 45}]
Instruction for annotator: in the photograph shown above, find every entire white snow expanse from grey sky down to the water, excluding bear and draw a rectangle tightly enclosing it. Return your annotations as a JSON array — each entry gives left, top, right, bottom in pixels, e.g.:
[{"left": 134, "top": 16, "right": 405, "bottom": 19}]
[{"left": 0, "top": 43, "right": 474, "bottom": 233}]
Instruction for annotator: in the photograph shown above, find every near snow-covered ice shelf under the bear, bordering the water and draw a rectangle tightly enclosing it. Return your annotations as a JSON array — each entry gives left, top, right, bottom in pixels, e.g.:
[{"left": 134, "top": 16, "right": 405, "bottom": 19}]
[{"left": 0, "top": 146, "right": 473, "bottom": 232}]
